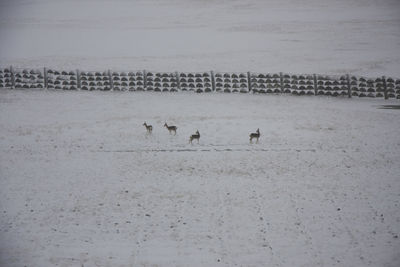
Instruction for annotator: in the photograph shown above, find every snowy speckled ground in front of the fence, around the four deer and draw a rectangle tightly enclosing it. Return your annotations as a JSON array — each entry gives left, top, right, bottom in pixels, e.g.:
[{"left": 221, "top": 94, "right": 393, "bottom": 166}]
[{"left": 0, "top": 90, "right": 400, "bottom": 267}]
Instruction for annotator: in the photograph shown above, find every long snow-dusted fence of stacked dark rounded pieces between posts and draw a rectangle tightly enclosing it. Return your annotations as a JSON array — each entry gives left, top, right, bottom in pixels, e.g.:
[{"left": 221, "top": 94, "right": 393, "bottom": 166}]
[{"left": 0, "top": 69, "right": 400, "bottom": 98}]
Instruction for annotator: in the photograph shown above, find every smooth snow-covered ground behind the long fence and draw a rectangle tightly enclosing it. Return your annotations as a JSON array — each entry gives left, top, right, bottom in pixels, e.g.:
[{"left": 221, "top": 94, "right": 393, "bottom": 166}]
[{"left": 0, "top": 0, "right": 400, "bottom": 78}]
